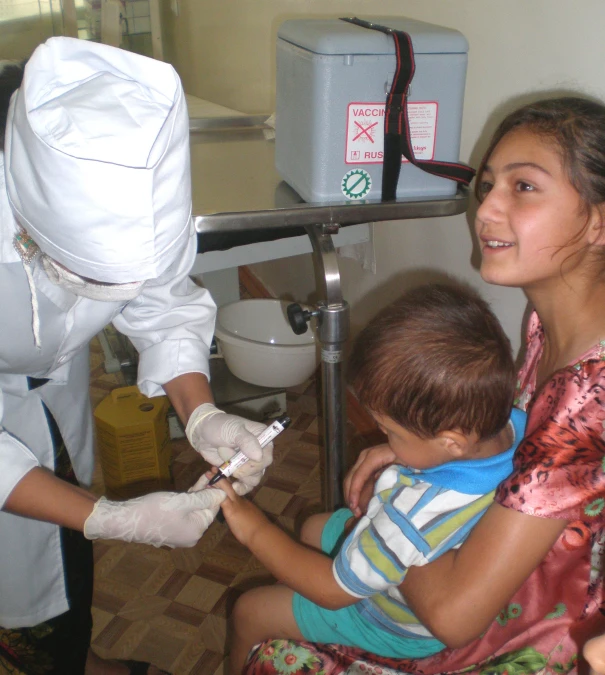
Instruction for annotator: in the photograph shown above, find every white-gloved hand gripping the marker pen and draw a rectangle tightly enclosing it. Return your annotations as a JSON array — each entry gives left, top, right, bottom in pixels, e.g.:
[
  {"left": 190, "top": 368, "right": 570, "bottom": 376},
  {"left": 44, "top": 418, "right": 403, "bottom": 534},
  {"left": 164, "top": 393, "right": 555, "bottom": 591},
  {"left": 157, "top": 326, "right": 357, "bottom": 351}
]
[{"left": 185, "top": 403, "right": 273, "bottom": 494}]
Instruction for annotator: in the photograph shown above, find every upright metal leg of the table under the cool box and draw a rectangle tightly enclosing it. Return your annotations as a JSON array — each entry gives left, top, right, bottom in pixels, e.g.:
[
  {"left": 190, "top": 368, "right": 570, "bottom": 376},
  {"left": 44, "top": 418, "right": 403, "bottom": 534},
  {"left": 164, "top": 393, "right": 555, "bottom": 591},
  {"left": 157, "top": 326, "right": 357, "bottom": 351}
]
[{"left": 305, "top": 225, "right": 350, "bottom": 511}]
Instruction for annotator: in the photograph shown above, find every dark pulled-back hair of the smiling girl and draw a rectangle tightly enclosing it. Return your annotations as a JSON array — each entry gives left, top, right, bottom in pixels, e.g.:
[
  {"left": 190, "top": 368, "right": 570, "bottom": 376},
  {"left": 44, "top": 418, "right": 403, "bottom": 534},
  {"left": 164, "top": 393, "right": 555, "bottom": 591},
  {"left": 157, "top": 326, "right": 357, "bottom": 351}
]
[{"left": 475, "top": 96, "right": 605, "bottom": 208}]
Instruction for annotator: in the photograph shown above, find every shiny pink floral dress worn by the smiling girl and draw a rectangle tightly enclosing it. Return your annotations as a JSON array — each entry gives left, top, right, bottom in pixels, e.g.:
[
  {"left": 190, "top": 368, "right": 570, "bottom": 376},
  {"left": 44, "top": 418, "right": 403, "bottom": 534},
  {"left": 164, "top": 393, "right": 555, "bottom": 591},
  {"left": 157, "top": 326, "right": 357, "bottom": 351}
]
[{"left": 244, "top": 314, "right": 605, "bottom": 675}]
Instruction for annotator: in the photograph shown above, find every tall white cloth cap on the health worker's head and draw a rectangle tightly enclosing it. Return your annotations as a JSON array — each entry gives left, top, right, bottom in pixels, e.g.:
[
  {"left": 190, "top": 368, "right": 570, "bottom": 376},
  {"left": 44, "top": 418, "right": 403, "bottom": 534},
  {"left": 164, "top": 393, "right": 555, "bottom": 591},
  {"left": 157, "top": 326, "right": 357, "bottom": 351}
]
[{"left": 5, "top": 37, "right": 191, "bottom": 283}]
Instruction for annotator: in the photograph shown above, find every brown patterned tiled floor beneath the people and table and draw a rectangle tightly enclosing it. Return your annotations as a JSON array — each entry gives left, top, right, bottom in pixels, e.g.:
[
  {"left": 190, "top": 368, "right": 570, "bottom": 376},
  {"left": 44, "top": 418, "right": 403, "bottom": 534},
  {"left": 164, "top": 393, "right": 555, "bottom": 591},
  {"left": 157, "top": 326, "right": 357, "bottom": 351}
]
[{"left": 86, "top": 294, "right": 378, "bottom": 675}]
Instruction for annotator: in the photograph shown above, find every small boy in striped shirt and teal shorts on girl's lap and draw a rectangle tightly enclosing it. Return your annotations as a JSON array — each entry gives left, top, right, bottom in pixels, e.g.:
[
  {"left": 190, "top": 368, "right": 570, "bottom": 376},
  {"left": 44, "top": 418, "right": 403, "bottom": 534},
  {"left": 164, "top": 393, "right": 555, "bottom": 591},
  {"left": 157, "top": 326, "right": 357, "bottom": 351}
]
[{"left": 218, "top": 285, "right": 525, "bottom": 674}]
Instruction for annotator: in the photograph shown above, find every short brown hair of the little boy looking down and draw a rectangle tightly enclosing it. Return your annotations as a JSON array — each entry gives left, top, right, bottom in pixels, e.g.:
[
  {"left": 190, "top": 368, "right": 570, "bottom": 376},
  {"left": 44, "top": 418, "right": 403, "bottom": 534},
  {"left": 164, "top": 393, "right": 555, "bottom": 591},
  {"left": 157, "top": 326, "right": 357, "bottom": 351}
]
[{"left": 348, "top": 283, "right": 516, "bottom": 440}]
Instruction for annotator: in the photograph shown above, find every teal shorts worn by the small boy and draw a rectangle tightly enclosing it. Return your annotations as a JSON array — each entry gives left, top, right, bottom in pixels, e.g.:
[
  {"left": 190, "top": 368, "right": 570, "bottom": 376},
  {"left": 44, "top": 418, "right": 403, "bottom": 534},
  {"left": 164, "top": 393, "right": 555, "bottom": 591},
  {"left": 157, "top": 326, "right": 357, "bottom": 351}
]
[{"left": 292, "top": 509, "right": 445, "bottom": 658}]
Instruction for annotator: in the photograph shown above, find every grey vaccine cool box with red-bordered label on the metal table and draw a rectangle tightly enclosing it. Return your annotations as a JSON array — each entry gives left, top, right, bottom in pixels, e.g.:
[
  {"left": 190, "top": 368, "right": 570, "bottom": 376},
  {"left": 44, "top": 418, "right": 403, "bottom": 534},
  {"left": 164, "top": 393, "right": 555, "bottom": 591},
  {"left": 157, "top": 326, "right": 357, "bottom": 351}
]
[{"left": 275, "top": 17, "right": 468, "bottom": 202}]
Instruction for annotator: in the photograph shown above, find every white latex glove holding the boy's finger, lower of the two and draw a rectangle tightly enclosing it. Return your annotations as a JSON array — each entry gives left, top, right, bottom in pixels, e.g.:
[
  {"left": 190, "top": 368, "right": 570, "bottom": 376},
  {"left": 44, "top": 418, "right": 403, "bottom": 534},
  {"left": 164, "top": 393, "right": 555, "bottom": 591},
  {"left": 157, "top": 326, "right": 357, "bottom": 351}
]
[{"left": 84, "top": 489, "right": 225, "bottom": 548}]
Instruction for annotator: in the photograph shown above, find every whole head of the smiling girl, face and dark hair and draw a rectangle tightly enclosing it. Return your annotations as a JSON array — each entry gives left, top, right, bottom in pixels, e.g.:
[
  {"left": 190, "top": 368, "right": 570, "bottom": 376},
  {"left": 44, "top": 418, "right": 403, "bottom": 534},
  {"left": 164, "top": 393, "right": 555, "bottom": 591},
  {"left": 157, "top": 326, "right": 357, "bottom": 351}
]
[{"left": 475, "top": 97, "right": 605, "bottom": 291}]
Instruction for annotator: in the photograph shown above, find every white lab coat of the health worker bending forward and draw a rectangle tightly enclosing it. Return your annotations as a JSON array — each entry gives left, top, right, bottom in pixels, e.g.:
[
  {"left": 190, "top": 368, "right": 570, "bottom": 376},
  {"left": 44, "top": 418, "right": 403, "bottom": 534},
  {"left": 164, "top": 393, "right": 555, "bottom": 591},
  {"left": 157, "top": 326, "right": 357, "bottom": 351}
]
[{"left": 0, "top": 165, "right": 216, "bottom": 628}]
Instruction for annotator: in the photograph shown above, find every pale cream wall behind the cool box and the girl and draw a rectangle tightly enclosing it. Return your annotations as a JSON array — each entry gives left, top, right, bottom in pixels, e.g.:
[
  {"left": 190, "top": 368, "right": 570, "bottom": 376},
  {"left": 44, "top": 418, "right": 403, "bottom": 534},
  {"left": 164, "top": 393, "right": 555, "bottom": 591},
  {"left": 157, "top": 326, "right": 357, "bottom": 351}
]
[{"left": 165, "top": 0, "right": 605, "bottom": 356}]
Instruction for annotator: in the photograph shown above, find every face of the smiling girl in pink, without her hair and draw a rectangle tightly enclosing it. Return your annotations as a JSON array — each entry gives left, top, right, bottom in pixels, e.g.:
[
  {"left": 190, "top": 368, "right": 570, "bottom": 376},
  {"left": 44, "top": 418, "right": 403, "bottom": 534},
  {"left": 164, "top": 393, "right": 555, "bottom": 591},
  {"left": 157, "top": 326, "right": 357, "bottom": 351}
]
[{"left": 475, "top": 129, "right": 595, "bottom": 291}]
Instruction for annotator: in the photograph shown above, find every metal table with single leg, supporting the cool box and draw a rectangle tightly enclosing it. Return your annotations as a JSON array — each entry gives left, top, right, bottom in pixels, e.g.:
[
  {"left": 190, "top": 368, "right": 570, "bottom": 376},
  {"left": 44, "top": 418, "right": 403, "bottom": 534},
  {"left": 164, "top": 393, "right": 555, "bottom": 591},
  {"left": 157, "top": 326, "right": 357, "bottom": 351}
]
[{"left": 191, "top": 116, "right": 468, "bottom": 510}]
